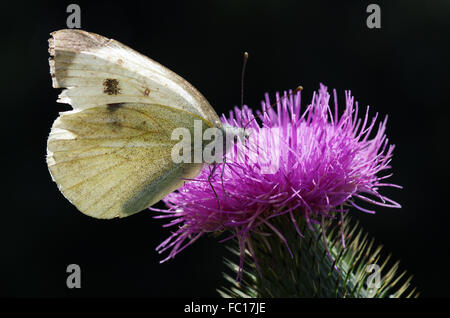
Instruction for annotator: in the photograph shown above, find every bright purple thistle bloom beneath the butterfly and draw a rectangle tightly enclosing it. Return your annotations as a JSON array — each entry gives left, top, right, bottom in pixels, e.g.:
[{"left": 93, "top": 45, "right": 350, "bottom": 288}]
[{"left": 152, "top": 85, "right": 401, "bottom": 269}]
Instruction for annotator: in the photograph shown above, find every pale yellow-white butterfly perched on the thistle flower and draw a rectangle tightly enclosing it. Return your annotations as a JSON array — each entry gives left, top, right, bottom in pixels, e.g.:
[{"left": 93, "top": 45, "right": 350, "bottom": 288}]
[{"left": 47, "top": 29, "right": 244, "bottom": 219}]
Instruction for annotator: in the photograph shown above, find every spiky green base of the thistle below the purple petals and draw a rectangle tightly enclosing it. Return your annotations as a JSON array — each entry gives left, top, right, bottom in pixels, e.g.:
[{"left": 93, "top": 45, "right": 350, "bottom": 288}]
[{"left": 219, "top": 217, "right": 418, "bottom": 298}]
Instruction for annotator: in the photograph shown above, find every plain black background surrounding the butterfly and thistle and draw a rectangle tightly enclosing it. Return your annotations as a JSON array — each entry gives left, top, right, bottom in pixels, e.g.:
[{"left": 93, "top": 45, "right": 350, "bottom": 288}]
[{"left": 0, "top": 1, "right": 450, "bottom": 297}]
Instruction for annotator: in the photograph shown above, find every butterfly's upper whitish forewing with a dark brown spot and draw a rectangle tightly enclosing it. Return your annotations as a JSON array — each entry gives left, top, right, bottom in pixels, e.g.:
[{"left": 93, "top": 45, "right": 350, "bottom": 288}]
[{"left": 49, "top": 29, "right": 221, "bottom": 126}]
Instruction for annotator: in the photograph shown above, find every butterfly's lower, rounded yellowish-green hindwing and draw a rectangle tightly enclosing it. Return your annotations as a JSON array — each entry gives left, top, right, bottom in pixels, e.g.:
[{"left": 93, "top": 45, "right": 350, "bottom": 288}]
[{"left": 47, "top": 103, "right": 206, "bottom": 218}]
